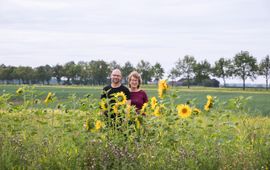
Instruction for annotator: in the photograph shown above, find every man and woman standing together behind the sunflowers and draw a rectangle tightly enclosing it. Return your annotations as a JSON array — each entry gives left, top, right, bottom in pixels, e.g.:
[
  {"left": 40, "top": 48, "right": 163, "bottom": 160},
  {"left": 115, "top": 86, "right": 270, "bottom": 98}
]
[{"left": 101, "top": 69, "right": 148, "bottom": 113}]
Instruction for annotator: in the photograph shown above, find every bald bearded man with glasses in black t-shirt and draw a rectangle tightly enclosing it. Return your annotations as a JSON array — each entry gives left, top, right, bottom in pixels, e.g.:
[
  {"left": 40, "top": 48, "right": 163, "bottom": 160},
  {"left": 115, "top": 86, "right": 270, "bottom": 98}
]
[{"left": 100, "top": 69, "right": 130, "bottom": 115}]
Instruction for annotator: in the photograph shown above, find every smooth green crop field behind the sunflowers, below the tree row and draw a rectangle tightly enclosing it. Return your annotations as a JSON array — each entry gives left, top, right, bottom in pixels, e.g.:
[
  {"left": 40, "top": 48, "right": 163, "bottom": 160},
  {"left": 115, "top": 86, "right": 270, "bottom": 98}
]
[{"left": 0, "top": 85, "right": 270, "bottom": 116}]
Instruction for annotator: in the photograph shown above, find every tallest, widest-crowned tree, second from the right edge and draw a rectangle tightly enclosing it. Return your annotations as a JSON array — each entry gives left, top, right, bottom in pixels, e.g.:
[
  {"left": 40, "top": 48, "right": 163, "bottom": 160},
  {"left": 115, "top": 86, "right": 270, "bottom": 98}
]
[{"left": 233, "top": 51, "right": 258, "bottom": 90}]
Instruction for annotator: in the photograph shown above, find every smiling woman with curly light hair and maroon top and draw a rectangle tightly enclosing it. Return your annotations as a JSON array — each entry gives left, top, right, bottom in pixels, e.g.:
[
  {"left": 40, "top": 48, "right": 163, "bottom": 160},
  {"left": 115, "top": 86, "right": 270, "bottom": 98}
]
[{"left": 128, "top": 71, "right": 148, "bottom": 113}]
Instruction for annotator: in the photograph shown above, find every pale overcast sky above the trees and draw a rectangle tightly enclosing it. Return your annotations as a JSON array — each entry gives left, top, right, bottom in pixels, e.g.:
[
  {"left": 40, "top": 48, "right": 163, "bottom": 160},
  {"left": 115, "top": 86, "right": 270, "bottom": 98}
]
[{"left": 0, "top": 0, "right": 270, "bottom": 83}]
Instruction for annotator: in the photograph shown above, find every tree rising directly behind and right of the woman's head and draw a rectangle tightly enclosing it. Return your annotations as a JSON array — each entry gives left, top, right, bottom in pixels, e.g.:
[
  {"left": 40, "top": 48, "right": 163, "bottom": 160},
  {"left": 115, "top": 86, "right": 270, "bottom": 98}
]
[{"left": 136, "top": 60, "right": 153, "bottom": 84}]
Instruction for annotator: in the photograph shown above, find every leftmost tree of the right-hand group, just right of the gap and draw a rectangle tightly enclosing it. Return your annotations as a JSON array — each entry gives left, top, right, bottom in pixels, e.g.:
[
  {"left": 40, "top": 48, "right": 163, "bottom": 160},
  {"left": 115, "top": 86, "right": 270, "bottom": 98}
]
[{"left": 175, "top": 55, "right": 196, "bottom": 88}]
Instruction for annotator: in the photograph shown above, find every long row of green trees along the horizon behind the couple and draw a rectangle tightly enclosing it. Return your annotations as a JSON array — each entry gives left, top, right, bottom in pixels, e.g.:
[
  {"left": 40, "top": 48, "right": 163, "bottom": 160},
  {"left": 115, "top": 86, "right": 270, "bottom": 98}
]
[{"left": 0, "top": 51, "right": 270, "bottom": 90}]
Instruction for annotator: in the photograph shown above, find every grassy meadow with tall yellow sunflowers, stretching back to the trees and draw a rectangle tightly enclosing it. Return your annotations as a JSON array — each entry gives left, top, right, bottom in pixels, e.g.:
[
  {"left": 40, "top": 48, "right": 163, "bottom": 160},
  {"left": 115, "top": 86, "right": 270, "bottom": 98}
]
[{"left": 0, "top": 85, "right": 270, "bottom": 169}]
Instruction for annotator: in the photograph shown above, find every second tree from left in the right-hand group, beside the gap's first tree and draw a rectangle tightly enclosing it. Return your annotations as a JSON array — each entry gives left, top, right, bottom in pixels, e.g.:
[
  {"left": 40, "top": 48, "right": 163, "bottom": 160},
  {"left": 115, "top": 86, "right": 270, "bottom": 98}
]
[{"left": 194, "top": 60, "right": 211, "bottom": 85}]
